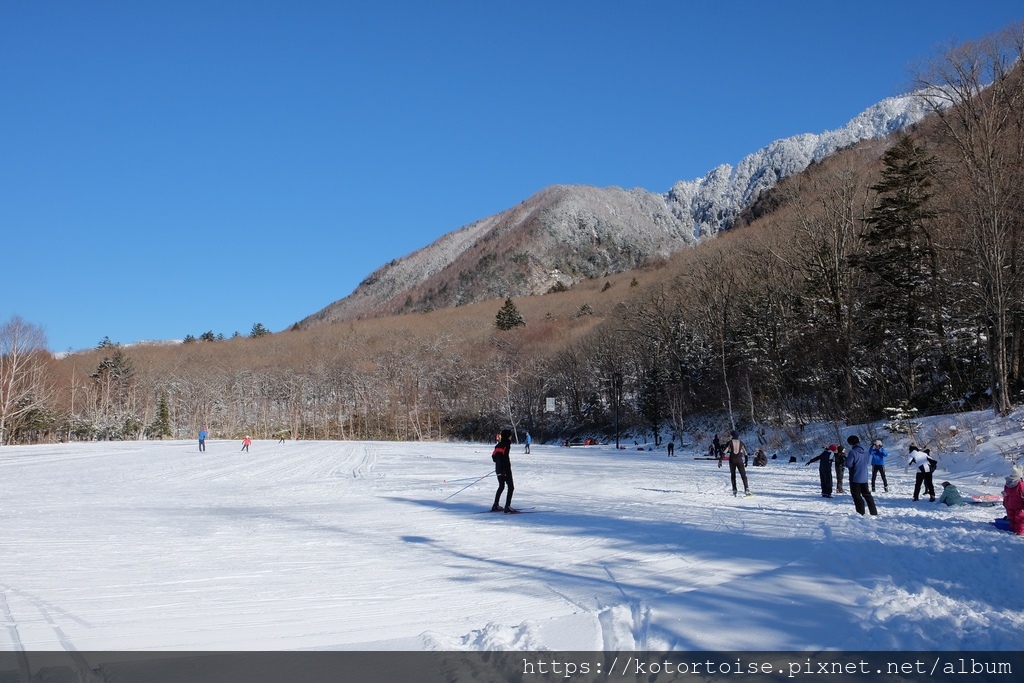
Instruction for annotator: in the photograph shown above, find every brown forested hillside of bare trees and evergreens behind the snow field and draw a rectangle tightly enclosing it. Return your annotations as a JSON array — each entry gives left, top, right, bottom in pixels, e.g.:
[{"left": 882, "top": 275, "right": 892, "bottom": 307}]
[{"left": 0, "top": 26, "right": 1024, "bottom": 442}]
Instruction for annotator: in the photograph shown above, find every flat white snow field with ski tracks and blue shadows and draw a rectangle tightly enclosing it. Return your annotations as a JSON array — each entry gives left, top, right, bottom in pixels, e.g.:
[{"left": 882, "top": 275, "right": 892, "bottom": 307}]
[{"left": 0, "top": 414, "right": 1024, "bottom": 652}]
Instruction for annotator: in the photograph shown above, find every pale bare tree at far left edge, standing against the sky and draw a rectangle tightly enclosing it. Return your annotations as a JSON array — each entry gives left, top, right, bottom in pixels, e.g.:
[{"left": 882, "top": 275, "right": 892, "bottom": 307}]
[{"left": 0, "top": 315, "right": 51, "bottom": 445}]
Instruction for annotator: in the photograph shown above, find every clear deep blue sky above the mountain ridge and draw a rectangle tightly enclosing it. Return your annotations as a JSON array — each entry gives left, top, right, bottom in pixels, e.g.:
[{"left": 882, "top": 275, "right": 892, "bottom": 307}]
[{"left": 0, "top": 0, "right": 1024, "bottom": 350}]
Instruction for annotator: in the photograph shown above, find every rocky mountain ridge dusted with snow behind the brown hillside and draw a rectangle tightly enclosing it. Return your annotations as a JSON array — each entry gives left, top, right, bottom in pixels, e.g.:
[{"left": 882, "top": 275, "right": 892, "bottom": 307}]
[{"left": 300, "top": 95, "right": 928, "bottom": 327}]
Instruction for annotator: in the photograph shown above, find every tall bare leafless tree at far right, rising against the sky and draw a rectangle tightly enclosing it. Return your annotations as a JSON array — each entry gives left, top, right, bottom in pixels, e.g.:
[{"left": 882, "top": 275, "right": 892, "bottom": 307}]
[{"left": 918, "top": 24, "right": 1024, "bottom": 414}]
